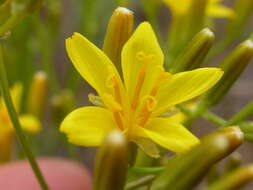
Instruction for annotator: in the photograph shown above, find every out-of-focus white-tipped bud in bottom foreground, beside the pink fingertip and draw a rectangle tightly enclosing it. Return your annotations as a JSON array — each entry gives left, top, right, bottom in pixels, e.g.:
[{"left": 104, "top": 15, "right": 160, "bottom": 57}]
[{"left": 94, "top": 131, "right": 128, "bottom": 190}]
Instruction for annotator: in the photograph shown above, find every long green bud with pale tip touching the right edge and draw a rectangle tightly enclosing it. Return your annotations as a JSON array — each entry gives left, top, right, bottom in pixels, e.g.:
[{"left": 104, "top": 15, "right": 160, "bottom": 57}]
[{"left": 199, "top": 40, "right": 253, "bottom": 108}]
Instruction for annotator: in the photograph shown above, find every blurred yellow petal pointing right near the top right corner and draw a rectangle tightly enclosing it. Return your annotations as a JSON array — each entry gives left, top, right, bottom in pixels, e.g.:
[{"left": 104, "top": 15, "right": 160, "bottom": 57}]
[{"left": 207, "top": 5, "right": 236, "bottom": 18}]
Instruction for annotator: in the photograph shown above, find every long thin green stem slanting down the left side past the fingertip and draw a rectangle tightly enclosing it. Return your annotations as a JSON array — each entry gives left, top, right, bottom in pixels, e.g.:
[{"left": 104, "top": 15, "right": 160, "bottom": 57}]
[{"left": 0, "top": 42, "right": 48, "bottom": 190}]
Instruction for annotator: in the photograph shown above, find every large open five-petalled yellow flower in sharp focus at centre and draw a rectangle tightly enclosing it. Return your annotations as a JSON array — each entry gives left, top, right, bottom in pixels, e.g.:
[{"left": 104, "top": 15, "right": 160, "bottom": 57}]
[{"left": 60, "top": 22, "right": 223, "bottom": 156}]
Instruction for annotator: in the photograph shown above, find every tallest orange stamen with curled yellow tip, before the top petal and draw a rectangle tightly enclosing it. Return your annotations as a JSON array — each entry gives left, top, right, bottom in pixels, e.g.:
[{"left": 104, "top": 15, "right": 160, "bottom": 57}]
[{"left": 132, "top": 51, "right": 153, "bottom": 109}]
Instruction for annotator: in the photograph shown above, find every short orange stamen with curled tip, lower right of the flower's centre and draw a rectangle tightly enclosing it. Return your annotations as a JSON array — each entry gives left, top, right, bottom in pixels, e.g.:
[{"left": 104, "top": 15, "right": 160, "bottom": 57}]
[{"left": 138, "top": 96, "right": 157, "bottom": 126}]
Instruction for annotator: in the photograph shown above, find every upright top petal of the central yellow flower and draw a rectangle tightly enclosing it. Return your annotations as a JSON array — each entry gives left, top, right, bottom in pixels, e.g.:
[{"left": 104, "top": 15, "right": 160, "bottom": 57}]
[{"left": 122, "top": 22, "right": 164, "bottom": 100}]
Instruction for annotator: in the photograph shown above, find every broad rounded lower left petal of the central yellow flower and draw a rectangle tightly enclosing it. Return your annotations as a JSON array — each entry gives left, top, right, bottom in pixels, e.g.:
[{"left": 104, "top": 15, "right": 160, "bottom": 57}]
[{"left": 60, "top": 106, "right": 117, "bottom": 146}]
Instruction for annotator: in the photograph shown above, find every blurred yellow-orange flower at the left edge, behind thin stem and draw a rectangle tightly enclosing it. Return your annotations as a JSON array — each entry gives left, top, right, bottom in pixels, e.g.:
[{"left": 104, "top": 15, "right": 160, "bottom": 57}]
[{"left": 0, "top": 83, "right": 40, "bottom": 162}]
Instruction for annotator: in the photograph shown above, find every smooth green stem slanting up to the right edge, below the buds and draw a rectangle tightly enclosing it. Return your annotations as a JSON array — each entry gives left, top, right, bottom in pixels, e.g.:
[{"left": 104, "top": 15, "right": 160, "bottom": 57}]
[{"left": 225, "top": 101, "right": 253, "bottom": 126}]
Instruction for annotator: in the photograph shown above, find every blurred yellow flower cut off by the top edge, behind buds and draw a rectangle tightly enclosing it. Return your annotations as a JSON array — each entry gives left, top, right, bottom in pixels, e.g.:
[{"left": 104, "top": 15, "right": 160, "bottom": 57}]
[{"left": 163, "top": 0, "right": 235, "bottom": 18}]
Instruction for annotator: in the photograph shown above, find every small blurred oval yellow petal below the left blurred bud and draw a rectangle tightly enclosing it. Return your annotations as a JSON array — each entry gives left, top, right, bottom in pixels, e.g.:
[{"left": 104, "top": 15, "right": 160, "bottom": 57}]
[{"left": 19, "top": 114, "right": 41, "bottom": 133}]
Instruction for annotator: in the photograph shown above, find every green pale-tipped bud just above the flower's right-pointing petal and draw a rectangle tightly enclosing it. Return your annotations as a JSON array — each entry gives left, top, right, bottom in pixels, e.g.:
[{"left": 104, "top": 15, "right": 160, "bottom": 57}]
[{"left": 170, "top": 28, "right": 214, "bottom": 73}]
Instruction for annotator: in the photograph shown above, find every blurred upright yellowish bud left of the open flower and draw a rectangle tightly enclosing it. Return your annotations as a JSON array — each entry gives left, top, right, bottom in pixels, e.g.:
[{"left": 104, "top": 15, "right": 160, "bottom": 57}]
[{"left": 28, "top": 71, "right": 48, "bottom": 118}]
